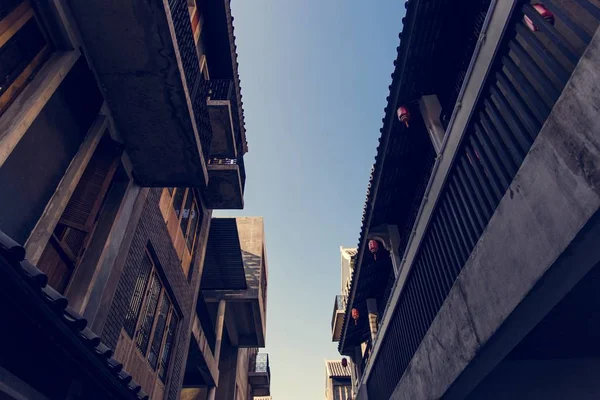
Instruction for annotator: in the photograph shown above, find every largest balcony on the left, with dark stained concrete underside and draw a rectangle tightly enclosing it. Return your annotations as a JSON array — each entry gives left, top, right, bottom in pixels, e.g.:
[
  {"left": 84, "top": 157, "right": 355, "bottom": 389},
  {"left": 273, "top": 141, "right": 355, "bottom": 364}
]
[{"left": 69, "top": 0, "right": 213, "bottom": 187}]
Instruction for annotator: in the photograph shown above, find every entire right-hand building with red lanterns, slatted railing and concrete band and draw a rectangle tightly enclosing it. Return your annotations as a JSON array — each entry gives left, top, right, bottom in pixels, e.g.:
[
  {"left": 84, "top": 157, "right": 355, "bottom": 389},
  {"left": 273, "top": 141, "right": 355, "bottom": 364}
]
[{"left": 339, "top": 0, "right": 600, "bottom": 400}]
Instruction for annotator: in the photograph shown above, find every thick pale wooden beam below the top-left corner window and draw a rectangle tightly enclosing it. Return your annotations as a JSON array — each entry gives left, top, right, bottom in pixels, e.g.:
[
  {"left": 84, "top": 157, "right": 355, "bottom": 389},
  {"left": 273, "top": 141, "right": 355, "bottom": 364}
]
[{"left": 0, "top": 50, "right": 81, "bottom": 167}]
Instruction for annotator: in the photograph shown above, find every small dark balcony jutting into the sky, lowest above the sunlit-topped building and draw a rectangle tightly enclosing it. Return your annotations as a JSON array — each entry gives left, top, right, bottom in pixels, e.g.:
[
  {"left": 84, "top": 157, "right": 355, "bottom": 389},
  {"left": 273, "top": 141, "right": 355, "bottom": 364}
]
[{"left": 206, "top": 157, "right": 246, "bottom": 210}]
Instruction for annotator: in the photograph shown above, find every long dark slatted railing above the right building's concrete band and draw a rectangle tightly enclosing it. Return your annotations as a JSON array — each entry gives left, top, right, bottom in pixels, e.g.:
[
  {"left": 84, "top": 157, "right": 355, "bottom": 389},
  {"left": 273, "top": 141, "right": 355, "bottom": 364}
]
[{"left": 367, "top": 0, "right": 600, "bottom": 398}]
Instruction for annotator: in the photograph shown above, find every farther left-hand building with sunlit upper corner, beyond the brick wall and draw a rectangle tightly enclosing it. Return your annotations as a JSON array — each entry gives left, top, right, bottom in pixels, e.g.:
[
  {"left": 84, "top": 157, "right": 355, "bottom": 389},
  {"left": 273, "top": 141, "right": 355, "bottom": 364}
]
[{"left": 182, "top": 217, "right": 271, "bottom": 400}]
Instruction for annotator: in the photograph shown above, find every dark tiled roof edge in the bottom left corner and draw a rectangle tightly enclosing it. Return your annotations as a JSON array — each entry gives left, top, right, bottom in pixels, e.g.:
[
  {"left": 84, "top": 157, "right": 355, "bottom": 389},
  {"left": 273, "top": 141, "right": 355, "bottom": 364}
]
[{"left": 0, "top": 231, "right": 149, "bottom": 400}]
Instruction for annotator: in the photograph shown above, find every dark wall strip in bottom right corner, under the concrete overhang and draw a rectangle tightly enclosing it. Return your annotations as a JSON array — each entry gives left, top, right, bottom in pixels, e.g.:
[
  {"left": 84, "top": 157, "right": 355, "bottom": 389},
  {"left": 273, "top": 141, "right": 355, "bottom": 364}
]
[{"left": 467, "top": 359, "right": 600, "bottom": 400}]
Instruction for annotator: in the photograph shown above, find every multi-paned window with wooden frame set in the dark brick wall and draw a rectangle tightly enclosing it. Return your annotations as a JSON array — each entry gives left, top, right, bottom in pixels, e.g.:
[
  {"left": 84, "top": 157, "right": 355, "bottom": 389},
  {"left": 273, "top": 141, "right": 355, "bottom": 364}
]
[{"left": 126, "top": 258, "right": 179, "bottom": 383}]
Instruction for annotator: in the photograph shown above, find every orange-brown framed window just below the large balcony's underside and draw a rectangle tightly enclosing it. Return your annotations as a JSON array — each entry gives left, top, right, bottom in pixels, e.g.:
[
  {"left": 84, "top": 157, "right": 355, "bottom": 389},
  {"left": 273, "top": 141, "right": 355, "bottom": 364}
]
[{"left": 160, "top": 188, "right": 203, "bottom": 276}]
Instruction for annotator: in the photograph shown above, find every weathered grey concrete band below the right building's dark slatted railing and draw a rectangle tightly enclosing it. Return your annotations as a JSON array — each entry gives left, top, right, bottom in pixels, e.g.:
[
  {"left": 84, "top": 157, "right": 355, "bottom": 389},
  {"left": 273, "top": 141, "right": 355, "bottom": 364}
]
[{"left": 392, "top": 28, "right": 600, "bottom": 399}]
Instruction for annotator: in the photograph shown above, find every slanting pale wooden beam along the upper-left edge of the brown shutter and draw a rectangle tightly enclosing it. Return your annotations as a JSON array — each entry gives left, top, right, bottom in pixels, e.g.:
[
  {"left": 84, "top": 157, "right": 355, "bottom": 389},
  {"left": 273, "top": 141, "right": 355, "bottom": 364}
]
[{"left": 25, "top": 115, "right": 107, "bottom": 264}]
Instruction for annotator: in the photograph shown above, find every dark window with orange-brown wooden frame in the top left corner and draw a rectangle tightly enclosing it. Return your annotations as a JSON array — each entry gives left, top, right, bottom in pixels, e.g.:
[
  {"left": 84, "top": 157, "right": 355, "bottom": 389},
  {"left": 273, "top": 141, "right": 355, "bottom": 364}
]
[{"left": 0, "top": 0, "right": 51, "bottom": 115}]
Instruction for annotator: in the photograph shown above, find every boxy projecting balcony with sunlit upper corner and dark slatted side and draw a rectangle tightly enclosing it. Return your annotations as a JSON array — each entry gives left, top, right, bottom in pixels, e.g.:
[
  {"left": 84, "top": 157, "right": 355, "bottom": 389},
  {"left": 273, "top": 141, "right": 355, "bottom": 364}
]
[{"left": 200, "top": 217, "right": 267, "bottom": 347}]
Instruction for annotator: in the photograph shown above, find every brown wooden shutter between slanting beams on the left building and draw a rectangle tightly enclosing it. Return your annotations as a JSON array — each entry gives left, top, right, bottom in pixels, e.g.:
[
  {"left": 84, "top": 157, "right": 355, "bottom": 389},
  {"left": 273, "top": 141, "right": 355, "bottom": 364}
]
[{"left": 38, "top": 136, "right": 120, "bottom": 293}]
